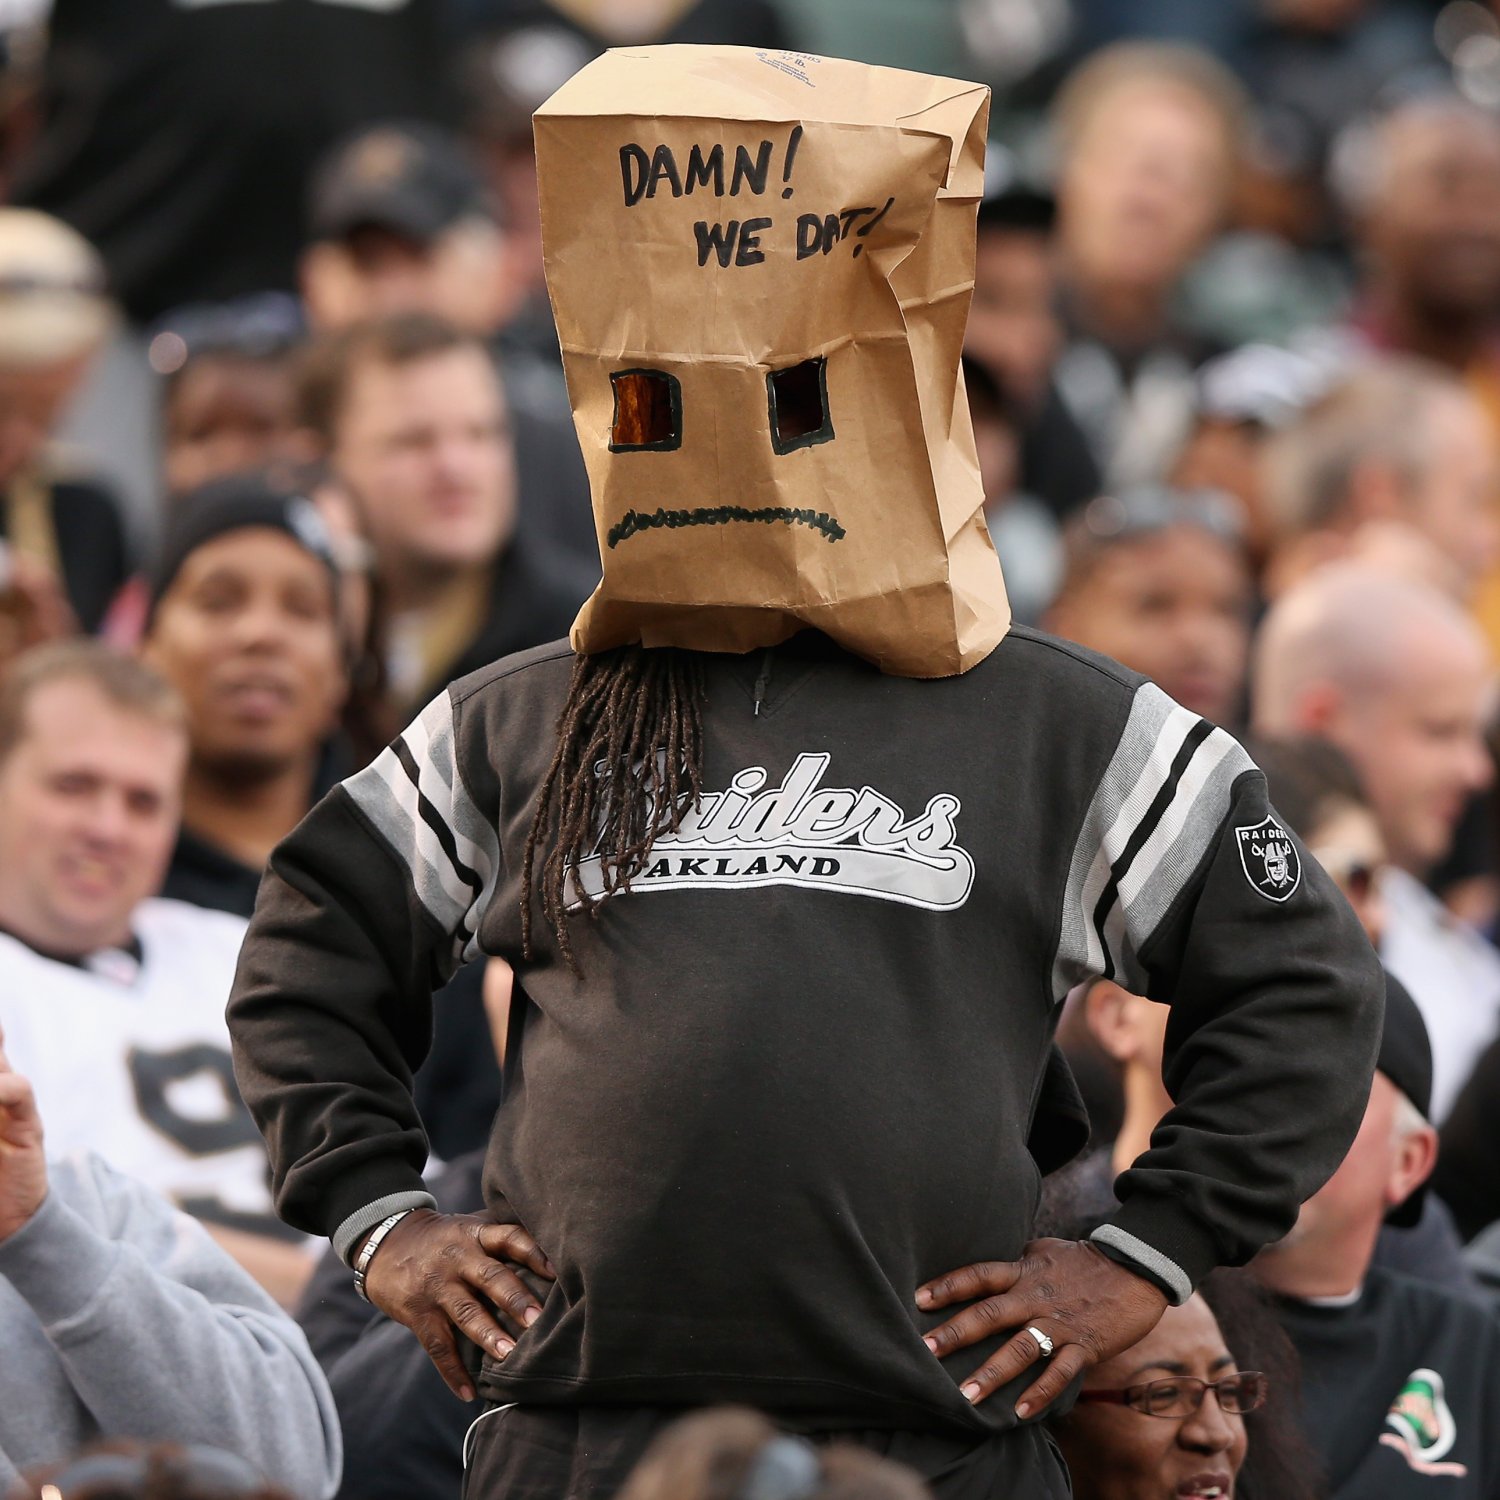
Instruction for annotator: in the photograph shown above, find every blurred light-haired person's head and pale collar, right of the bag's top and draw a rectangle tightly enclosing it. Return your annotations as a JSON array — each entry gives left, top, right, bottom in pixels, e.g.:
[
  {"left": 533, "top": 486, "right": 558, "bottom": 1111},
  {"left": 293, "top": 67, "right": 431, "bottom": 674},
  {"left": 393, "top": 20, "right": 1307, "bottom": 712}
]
[{"left": 1055, "top": 44, "right": 1242, "bottom": 486}]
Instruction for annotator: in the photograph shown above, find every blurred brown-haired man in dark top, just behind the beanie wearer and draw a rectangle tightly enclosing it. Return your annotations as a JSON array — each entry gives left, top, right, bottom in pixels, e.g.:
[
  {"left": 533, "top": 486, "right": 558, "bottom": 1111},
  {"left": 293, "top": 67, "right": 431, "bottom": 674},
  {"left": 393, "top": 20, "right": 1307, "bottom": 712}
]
[{"left": 292, "top": 314, "right": 591, "bottom": 738}]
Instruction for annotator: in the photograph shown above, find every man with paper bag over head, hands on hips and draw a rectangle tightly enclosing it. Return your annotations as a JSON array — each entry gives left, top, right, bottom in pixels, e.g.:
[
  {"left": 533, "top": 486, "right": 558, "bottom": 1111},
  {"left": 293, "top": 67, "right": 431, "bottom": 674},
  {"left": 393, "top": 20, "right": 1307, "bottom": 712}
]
[{"left": 230, "top": 48, "right": 1382, "bottom": 1500}]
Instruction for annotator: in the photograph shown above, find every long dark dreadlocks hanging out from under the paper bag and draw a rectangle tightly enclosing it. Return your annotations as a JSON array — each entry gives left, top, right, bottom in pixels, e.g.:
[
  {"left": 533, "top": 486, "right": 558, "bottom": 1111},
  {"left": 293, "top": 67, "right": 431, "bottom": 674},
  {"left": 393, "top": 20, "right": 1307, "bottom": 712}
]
[{"left": 521, "top": 645, "right": 704, "bottom": 974}]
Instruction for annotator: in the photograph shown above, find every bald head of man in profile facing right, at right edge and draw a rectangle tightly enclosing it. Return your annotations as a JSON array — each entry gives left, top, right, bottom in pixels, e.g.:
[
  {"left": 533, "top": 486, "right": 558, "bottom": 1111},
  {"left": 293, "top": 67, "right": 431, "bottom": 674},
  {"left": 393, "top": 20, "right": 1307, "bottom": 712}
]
[{"left": 1253, "top": 566, "right": 1493, "bottom": 876}]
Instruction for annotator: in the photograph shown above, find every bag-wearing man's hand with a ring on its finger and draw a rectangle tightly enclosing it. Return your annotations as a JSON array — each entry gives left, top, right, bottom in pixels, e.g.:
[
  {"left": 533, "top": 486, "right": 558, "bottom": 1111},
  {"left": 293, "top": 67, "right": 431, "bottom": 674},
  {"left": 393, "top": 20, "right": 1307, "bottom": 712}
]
[{"left": 917, "top": 1239, "right": 1167, "bottom": 1419}]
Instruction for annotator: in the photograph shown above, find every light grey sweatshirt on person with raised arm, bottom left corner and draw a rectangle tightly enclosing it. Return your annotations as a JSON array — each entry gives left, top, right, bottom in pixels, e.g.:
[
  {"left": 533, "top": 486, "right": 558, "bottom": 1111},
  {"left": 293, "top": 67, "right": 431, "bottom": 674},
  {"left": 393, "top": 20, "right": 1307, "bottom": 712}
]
[{"left": 0, "top": 1157, "right": 344, "bottom": 1500}]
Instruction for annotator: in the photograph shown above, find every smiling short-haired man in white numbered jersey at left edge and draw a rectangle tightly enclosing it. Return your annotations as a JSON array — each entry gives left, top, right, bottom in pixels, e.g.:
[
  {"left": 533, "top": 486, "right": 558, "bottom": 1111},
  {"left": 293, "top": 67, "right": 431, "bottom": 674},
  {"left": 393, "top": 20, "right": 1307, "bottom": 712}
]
[{"left": 0, "top": 641, "right": 311, "bottom": 1302}]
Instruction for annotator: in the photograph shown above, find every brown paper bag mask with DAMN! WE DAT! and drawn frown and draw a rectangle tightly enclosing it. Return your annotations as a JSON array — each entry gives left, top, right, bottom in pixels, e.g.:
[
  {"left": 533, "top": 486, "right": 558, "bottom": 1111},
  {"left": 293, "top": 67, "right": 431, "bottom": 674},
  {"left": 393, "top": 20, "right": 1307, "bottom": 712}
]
[{"left": 536, "top": 47, "right": 1010, "bottom": 677}]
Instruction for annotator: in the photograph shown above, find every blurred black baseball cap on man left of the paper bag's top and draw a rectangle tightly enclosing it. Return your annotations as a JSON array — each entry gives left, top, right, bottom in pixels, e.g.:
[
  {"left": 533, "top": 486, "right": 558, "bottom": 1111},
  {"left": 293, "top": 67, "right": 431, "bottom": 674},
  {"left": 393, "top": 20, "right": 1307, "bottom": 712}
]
[{"left": 308, "top": 122, "right": 498, "bottom": 245}]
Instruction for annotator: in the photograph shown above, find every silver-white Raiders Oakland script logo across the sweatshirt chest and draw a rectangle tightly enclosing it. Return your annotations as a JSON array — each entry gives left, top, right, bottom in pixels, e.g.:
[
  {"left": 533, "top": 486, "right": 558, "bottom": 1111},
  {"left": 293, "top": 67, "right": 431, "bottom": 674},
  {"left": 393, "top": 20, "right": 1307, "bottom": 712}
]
[{"left": 572, "top": 755, "right": 974, "bottom": 912}]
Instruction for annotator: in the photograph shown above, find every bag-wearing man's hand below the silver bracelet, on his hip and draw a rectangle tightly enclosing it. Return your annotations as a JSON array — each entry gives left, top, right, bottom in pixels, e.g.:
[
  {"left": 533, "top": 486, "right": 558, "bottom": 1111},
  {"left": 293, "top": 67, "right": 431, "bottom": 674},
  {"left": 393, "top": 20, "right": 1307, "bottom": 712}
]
[{"left": 365, "top": 1209, "right": 557, "bottom": 1401}]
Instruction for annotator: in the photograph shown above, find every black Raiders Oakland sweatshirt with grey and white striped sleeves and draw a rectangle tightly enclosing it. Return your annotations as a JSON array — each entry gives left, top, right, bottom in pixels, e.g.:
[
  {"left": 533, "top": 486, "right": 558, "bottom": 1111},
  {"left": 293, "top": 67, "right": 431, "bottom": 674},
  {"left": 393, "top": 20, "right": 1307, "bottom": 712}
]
[{"left": 230, "top": 629, "right": 1383, "bottom": 1430}]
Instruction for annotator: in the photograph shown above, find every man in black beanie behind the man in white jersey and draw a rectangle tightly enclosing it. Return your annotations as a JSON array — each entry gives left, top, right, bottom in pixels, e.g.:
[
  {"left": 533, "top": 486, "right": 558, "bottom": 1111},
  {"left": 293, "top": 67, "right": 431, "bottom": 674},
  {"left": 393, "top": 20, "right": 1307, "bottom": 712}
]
[{"left": 143, "top": 476, "right": 347, "bottom": 917}]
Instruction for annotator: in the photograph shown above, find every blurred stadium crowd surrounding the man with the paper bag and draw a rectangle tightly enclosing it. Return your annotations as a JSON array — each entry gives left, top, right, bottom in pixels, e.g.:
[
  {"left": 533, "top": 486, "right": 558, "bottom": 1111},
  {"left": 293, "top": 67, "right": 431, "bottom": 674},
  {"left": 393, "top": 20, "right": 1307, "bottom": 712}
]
[{"left": 0, "top": 0, "right": 1500, "bottom": 1500}]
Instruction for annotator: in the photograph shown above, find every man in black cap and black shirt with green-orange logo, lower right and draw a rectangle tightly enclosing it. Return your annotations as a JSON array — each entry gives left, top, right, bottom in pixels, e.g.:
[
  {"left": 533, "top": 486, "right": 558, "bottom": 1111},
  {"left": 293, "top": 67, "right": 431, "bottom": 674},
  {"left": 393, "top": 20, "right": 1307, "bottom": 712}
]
[{"left": 1253, "top": 977, "right": 1500, "bottom": 1500}]
